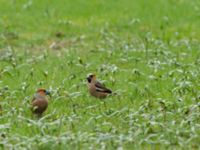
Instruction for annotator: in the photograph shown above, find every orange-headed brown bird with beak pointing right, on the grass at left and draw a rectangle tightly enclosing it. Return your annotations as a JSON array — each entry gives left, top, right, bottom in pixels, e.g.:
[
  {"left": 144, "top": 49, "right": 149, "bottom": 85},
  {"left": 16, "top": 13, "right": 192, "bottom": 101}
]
[{"left": 31, "top": 88, "right": 50, "bottom": 118}]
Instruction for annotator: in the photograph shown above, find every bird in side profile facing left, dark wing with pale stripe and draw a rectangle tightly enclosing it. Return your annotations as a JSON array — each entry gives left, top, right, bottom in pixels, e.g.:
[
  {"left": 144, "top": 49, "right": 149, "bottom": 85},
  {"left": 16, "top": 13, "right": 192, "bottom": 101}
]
[{"left": 87, "top": 74, "right": 112, "bottom": 99}]
